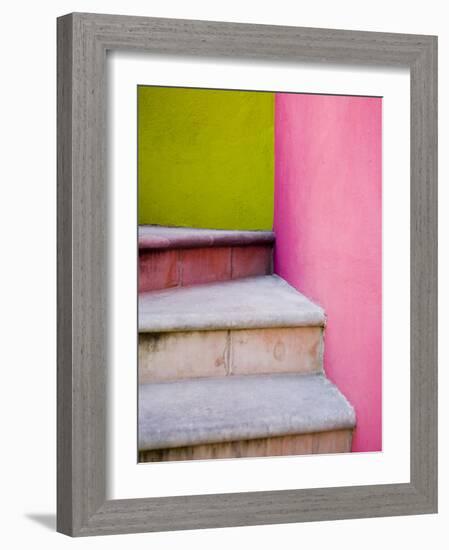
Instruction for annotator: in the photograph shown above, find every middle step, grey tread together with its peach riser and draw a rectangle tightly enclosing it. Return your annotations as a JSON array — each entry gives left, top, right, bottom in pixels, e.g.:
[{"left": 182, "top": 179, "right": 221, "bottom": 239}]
[{"left": 139, "top": 276, "right": 325, "bottom": 384}]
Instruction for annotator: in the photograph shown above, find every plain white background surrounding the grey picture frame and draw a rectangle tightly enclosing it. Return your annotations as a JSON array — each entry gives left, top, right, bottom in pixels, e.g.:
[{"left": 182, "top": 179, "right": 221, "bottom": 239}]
[{"left": 0, "top": 0, "right": 440, "bottom": 549}]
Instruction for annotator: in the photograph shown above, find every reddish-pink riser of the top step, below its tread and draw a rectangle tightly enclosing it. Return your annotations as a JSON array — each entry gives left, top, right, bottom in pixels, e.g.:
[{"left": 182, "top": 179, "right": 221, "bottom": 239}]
[{"left": 139, "top": 245, "right": 273, "bottom": 292}]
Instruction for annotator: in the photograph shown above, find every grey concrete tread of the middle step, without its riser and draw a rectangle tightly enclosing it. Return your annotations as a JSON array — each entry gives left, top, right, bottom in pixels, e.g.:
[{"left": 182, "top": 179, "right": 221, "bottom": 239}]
[{"left": 139, "top": 275, "right": 326, "bottom": 332}]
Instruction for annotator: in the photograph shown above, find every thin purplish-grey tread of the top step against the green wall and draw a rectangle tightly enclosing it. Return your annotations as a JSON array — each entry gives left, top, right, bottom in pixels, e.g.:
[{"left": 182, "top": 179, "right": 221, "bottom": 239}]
[{"left": 139, "top": 225, "right": 275, "bottom": 249}]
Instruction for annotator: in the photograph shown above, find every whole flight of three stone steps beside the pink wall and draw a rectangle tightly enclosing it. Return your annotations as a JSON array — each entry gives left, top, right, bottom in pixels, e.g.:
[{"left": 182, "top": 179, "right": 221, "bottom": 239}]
[{"left": 139, "top": 226, "right": 355, "bottom": 462}]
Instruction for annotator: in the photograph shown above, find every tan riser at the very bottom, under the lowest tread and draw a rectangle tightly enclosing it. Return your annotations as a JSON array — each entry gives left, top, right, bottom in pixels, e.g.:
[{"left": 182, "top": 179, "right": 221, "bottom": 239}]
[{"left": 139, "top": 430, "right": 352, "bottom": 462}]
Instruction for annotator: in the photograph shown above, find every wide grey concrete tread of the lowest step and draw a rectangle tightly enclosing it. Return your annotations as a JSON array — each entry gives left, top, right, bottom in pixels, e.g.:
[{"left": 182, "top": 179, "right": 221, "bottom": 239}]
[{"left": 139, "top": 374, "right": 355, "bottom": 451}]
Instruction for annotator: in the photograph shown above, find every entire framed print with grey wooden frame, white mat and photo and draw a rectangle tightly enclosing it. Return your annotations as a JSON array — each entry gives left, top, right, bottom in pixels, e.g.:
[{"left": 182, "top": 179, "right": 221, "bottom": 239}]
[{"left": 58, "top": 14, "right": 437, "bottom": 536}]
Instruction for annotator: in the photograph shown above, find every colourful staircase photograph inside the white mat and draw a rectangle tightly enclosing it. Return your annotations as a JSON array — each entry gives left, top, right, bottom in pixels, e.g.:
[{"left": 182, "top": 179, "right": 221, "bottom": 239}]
[{"left": 136, "top": 84, "right": 382, "bottom": 463}]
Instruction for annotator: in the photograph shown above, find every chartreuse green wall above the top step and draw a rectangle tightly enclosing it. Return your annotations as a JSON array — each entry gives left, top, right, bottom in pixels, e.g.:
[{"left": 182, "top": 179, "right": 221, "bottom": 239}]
[{"left": 137, "top": 86, "right": 274, "bottom": 230}]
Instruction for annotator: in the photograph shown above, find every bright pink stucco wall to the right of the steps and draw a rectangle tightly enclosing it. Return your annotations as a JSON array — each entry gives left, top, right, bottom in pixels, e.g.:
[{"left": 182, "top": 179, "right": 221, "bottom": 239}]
[{"left": 274, "top": 94, "right": 382, "bottom": 451}]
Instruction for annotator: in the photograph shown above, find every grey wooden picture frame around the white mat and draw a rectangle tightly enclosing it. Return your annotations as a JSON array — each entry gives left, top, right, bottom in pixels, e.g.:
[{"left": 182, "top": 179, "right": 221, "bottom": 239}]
[{"left": 57, "top": 13, "right": 437, "bottom": 536}]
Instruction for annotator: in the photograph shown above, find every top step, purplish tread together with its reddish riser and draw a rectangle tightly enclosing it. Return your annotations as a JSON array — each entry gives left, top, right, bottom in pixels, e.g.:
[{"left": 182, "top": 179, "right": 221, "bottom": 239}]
[{"left": 139, "top": 225, "right": 274, "bottom": 292}]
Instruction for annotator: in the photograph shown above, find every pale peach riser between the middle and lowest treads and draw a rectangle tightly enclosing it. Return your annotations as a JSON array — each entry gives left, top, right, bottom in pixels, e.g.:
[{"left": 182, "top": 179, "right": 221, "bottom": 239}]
[{"left": 139, "top": 327, "right": 323, "bottom": 384}]
